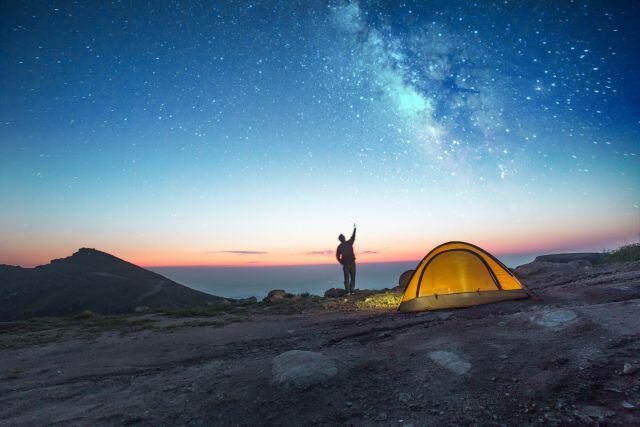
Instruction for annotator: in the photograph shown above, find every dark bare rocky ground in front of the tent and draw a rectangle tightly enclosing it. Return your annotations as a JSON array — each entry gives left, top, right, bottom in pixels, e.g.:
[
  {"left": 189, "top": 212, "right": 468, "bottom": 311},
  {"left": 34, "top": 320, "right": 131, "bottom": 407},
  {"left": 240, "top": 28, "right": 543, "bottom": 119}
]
[{"left": 0, "top": 262, "right": 640, "bottom": 426}]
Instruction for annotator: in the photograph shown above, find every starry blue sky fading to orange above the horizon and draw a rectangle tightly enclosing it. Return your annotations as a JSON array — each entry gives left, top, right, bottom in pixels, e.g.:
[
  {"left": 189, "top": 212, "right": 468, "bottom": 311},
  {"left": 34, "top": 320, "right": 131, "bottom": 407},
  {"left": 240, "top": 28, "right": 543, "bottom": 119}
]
[{"left": 0, "top": 0, "right": 640, "bottom": 266}]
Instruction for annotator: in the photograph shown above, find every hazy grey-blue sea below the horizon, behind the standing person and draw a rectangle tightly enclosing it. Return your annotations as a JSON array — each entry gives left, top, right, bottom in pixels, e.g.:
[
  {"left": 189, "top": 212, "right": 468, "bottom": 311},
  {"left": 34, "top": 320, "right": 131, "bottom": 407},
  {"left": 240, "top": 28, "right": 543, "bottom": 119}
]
[{"left": 149, "top": 255, "right": 535, "bottom": 299}]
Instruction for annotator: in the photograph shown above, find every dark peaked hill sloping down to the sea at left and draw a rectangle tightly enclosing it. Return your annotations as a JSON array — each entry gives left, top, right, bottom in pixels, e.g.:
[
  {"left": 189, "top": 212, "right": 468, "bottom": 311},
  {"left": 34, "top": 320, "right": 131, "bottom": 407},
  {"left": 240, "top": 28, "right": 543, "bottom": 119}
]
[{"left": 0, "top": 248, "right": 222, "bottom": 321}]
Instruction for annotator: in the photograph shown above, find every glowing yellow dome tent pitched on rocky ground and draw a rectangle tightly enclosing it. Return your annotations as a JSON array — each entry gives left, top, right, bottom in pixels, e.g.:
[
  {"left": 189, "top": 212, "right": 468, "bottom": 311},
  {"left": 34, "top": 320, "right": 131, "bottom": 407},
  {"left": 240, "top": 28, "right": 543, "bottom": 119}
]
[{"left": 398, "top": 242, "right": 529, "bottom": 313}]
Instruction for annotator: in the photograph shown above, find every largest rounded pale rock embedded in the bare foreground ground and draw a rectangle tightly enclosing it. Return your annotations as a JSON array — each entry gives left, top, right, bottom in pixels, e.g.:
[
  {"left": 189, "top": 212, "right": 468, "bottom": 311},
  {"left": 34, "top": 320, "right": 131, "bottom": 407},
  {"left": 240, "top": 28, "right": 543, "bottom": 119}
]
[{"left": 272, "top": 350, "right": 338, "bottom": 388}]
